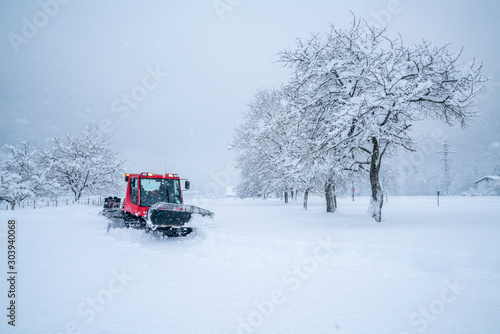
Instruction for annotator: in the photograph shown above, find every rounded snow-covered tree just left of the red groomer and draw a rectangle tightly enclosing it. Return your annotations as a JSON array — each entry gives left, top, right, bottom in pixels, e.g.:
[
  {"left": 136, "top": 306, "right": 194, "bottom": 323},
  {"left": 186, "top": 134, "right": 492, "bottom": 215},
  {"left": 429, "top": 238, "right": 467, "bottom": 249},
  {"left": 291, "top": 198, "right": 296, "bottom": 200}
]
[{"left": 39, "top": 125, "right": 124, "bottom": 201}]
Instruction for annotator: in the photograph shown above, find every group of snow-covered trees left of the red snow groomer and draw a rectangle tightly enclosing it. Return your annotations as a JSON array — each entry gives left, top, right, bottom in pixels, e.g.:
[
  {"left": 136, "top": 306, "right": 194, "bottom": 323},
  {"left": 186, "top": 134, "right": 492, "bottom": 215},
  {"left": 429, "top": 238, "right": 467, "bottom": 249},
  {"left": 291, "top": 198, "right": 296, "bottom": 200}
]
[{"left": 0, "top": 125, "right": 125, "bottom": 209}]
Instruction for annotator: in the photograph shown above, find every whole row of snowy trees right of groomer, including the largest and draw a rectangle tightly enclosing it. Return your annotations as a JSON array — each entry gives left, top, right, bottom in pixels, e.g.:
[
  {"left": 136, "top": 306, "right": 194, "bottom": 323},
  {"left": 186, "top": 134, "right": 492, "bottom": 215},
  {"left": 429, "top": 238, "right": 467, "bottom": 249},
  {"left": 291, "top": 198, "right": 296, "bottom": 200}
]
[{"left": 231, "top": 17, "right": 486, "bottom": 222}]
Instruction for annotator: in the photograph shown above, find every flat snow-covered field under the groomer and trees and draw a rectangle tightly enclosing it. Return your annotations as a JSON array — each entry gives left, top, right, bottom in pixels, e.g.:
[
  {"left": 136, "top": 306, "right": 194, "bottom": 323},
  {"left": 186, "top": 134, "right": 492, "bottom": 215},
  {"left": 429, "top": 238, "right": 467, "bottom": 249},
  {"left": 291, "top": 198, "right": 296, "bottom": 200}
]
[{"left": 0, "top": 197, "right": 500, "bottom": 334}]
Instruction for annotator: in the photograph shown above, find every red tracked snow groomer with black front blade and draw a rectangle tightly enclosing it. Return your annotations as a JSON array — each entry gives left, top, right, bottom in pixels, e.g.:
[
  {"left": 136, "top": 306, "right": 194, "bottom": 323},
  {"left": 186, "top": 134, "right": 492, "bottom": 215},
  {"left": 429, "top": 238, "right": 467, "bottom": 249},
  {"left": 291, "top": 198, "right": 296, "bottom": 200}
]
[{"left": 102, "top": 173, "right": 214, "bottom": 236}]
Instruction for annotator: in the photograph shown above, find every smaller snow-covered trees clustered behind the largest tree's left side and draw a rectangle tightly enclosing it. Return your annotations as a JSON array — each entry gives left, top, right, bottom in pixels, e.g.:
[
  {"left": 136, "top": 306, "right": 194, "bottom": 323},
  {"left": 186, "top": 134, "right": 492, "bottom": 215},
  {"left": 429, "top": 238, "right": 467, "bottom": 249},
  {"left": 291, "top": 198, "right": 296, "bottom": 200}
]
[{"left": 232, "top": 87, "right": 352, "bottom": 212}]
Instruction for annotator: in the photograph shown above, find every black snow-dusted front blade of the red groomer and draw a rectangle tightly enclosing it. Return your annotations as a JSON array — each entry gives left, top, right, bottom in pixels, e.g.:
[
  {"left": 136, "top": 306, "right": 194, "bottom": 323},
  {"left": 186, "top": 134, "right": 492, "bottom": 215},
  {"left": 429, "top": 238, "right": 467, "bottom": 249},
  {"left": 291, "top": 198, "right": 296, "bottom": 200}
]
[{"left": 146, "top": 202, "right": 214, "bottom": 229}]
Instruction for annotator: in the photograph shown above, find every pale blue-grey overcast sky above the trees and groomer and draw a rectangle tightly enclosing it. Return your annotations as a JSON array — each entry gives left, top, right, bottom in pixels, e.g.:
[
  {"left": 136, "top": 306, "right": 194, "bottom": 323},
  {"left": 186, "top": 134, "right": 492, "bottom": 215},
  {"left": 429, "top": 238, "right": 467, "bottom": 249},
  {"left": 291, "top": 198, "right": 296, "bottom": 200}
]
[{"left": 0, "top": 0, "right": 500, "bottom": 192}]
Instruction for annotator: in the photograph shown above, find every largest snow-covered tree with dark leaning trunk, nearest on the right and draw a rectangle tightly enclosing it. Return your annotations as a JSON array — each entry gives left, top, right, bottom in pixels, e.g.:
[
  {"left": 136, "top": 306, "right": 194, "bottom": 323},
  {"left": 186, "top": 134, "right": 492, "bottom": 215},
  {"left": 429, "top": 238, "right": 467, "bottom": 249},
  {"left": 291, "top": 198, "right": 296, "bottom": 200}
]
[{"left": 280, "top": 18, "right": 484, "bottom": 222}]
